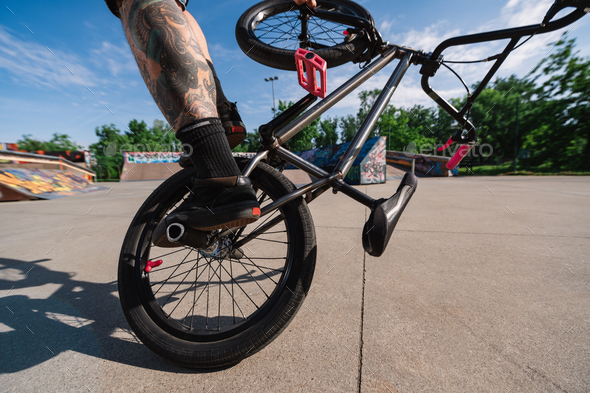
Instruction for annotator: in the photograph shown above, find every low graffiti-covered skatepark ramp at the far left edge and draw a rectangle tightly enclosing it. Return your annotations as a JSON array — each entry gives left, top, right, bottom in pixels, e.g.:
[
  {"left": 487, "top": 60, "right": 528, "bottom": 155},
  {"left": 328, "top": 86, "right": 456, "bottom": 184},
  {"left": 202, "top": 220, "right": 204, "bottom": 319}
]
[{"left": 0, "top": 150, "right": 105, "bottom": 201}]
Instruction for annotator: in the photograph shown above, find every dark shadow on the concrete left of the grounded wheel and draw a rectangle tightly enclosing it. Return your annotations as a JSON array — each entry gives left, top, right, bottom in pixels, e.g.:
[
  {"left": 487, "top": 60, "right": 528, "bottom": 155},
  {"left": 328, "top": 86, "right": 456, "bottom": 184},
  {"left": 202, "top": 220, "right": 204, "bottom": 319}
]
[{"left": 0, "top": 258, "right": 227, "bottom": 373}]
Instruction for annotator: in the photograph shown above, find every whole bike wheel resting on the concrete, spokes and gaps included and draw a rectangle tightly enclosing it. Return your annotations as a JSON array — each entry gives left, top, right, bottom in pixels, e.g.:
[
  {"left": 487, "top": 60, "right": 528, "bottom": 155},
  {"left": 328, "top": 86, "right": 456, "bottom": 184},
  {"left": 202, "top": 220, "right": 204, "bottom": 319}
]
[{"left": 119, "top": 161, "right": 316, "bottom": 368}]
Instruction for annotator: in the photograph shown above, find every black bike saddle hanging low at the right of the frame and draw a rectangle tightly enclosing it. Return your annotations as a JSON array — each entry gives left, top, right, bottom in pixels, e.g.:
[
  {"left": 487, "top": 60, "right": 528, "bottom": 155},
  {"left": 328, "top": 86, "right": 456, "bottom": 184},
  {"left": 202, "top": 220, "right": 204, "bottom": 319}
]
[{"left": 363, "top": 173, "right": 418, "bottom": 257}]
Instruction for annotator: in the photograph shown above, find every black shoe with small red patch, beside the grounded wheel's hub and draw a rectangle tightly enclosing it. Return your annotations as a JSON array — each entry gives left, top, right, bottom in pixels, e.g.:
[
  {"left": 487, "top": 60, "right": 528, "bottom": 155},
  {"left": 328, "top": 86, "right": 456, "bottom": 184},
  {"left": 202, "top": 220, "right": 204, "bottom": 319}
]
[{"left": 153, "top": 176, "right": 260, "bottom": 247}]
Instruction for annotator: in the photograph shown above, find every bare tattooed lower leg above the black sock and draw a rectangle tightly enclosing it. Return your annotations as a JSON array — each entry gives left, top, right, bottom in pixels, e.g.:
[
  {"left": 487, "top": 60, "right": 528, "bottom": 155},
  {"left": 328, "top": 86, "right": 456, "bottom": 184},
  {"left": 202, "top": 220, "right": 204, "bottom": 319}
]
[{"left": 121, "top": 0, "right": 218, "bottom": 130}]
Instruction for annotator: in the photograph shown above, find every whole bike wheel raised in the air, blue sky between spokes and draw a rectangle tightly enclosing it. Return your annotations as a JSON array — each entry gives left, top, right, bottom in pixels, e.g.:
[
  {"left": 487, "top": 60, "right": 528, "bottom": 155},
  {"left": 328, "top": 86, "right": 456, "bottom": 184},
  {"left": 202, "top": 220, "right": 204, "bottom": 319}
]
[{"left": 236, "top": 0, "right": 373, "bottom": 71}]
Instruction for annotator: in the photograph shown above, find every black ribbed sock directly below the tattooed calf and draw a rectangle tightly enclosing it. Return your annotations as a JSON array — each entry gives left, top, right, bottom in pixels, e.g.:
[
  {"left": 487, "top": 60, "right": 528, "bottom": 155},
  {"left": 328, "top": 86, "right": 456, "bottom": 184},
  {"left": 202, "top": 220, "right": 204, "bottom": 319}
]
[{"left": 176, "top": 117, "right": 241, "bottom": 179}]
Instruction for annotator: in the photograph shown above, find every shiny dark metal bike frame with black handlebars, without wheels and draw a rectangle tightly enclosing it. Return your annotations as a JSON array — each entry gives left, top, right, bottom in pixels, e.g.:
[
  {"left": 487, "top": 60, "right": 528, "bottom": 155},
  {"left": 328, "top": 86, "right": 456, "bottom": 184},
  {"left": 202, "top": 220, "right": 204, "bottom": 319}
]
[{"left": 234, "top": 0, "right": 586, "bottom": 230}]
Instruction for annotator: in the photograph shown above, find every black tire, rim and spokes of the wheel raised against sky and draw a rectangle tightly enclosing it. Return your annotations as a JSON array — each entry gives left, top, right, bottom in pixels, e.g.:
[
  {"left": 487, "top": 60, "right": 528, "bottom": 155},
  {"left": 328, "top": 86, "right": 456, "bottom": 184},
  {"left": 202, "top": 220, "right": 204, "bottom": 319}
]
[{"left": 236, "top": 0, "right": 373, "bottom": 71}]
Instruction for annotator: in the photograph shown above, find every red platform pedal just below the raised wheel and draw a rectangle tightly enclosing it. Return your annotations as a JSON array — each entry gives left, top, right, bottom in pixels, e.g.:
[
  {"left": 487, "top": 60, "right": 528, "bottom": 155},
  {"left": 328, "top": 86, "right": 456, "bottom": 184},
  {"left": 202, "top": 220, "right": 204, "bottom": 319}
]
[{"left": 295, "top": 48, "right": 328, "bottom": 98}]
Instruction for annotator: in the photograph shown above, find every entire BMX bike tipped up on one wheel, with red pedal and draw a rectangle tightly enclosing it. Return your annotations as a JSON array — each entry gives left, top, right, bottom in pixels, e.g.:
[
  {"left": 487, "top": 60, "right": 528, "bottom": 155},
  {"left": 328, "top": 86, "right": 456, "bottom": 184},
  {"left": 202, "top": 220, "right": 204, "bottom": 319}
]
[{"left": 118, "top": 0, "right": 590, "bottom": 368}]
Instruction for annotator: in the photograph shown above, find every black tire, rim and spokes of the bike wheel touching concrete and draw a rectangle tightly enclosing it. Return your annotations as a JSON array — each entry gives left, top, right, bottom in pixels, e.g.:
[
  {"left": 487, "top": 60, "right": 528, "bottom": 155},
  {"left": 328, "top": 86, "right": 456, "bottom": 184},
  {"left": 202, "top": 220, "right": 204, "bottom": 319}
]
[{"left": 118, "top": 159, "right": 316, "bottom": 368}]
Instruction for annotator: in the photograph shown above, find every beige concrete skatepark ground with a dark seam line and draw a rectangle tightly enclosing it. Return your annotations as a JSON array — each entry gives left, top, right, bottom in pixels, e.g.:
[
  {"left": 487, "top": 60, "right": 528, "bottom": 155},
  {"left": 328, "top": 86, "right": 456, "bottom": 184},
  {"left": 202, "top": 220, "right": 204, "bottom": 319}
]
[{"left": 0, "top": 177, "right": 590, "bottom": 393}]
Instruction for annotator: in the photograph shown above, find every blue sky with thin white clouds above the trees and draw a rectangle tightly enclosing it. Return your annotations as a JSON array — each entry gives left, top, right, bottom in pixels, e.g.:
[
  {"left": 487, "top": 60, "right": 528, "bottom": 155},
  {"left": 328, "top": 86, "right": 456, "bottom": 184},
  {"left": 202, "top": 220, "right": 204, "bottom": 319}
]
[{"left": 0, "top": 0, "right": 590, "bottom": 146}]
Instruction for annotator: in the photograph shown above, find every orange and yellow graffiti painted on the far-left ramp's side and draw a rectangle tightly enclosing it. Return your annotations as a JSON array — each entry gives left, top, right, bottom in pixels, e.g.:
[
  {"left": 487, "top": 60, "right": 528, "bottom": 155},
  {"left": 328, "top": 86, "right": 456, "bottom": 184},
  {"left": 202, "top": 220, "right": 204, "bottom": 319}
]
[{"left": 0, "top": 168, "right": 105, "bottom": 199}]
